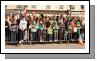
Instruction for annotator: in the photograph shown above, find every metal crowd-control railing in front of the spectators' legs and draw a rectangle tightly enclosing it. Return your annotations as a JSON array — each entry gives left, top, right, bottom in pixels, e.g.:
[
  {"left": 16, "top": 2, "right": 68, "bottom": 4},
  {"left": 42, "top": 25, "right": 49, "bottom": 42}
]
[{"left": 5, "top": 28, "right": 85, "bottom": 44}]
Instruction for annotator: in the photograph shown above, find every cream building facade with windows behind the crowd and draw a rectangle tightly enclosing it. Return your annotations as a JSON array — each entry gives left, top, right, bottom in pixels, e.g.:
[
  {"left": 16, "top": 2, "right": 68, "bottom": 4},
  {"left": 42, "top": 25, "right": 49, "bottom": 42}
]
[{"left": 5, "top": 5, "right": 85, "bottom": 16}]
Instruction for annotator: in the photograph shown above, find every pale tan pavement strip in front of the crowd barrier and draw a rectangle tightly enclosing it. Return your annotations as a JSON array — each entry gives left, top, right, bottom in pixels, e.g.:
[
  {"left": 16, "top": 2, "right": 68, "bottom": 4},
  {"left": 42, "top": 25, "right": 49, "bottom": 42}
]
[{"left": 5, "top": 43, "right": 85, "bottom": 49}]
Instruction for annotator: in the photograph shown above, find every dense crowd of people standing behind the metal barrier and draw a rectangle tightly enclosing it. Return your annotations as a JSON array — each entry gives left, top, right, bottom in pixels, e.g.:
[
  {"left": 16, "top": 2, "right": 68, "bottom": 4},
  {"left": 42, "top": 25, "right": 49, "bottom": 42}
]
[{"left": 5, "top": 12, "right": 85, "bottom": 42}]
